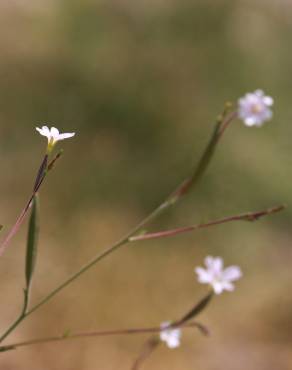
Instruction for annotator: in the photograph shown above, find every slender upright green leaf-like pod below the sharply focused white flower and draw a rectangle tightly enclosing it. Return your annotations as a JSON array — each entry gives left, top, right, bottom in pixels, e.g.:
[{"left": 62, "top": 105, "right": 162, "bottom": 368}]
[{"left": 25, "top": 194, "right": 39, "bottom": 290}]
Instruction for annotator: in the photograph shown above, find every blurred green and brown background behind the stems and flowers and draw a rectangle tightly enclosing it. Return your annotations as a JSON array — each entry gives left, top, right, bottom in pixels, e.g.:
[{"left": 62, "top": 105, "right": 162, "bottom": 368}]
[{"left": 0, "top": 0, "right": 292, "bottom": 370}]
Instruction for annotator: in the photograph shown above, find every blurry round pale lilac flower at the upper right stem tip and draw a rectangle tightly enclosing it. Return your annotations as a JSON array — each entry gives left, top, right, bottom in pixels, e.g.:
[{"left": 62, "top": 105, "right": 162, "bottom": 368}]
[{"left": 238, "top": 90, "right": 274, "bottom": 127}]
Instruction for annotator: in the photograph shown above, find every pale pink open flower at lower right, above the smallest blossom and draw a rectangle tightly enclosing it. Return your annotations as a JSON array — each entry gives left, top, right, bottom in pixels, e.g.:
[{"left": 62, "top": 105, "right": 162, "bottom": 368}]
[{"left": 195, "top": 256, "right": 242, "bottom": 294}]
